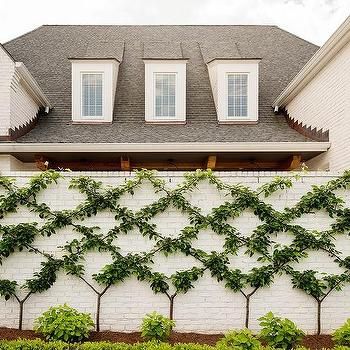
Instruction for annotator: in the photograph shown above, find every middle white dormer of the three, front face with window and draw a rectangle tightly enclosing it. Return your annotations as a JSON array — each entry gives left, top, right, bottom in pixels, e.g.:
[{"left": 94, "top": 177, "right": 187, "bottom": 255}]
[{"left": 144, "top": 59, "right": 187, "bottom": 123}]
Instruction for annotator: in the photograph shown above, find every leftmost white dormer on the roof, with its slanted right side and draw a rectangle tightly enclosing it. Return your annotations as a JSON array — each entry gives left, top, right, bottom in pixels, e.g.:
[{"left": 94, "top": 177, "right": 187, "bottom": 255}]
[{"left": 72, "top": 59, "right": 119, "bottom": 123}]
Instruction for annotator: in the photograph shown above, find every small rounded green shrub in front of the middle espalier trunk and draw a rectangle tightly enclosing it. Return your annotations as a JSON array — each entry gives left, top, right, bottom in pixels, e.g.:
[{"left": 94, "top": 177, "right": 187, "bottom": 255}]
[{"left": 141, "top": 311, "right": 175, "bottom": 341}]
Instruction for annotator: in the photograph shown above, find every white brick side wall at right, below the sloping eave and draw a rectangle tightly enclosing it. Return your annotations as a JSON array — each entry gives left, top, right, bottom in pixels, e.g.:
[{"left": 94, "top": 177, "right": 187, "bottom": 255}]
[{"left": 286, "top": 43, "right": 350, "bottom": 171}]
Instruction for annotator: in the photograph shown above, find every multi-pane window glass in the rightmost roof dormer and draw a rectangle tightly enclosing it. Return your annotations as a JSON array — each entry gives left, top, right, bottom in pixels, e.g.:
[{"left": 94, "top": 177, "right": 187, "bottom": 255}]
[{"left": 227, "top": 73, "right": 248, "bottom": 117}]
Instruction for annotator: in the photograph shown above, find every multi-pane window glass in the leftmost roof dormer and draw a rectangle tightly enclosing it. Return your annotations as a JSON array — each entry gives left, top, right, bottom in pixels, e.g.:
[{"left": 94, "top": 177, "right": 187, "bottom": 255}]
[{"left": 81, "top": 73, "right": 103, "bottom": 117}]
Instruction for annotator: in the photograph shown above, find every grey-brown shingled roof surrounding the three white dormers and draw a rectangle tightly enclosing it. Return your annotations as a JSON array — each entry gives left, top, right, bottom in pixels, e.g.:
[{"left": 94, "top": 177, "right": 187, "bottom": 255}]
[{"left": 5, "top": 26, "right": 317, "bottom": 143}]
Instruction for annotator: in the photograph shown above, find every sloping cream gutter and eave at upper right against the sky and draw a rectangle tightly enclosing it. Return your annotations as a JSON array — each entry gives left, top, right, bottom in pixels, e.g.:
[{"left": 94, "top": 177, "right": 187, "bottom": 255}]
[{"left": 272, "top": 16, "right": 350, "bottom": 108}]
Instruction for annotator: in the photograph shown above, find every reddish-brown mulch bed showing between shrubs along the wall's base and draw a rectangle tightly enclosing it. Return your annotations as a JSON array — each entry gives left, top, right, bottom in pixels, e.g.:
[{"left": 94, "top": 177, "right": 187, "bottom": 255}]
[{"left": 0, "top": 327, "right": 334, "bottom": 350}]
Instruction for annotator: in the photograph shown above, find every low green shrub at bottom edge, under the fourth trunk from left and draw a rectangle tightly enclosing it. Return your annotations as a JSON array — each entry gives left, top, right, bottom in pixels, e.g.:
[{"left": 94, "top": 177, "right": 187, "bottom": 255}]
[{"left": 216, "top": 329, "right": 261, "bottom": 350}]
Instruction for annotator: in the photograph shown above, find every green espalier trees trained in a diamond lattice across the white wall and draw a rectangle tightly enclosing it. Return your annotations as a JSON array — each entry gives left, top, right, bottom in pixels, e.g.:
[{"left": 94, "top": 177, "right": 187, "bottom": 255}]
[{"left": 0, "top": 170, "right": 350, "bottom": 333}]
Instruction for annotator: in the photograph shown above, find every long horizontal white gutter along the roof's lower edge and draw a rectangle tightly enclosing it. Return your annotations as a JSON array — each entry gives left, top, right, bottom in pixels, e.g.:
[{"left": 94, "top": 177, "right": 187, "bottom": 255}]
[{"left": 0, "top": 142, "right": 330, "bottom": 153}]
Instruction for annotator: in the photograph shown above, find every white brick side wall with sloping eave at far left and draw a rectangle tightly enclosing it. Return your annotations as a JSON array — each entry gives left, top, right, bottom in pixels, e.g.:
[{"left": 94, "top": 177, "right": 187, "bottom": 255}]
[{"left": 0, "top": 46, "right": 51, "bottom": 139}]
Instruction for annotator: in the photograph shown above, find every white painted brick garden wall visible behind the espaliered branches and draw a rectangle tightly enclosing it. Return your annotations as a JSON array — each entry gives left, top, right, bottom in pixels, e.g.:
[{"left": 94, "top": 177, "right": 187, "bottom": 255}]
[{"left": 0, "top": 172, "right": 350, "bottom": 333}]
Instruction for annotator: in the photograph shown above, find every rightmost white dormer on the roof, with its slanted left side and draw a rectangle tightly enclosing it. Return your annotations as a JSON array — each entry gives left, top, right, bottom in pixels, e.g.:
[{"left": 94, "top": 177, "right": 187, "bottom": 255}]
[{"left": 207, "top": 59, "right": 259, "bottom": 123}]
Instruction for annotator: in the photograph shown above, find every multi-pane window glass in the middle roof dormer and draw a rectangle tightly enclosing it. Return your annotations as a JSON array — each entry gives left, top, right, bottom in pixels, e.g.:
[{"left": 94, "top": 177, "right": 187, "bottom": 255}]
[{"left": 155, "top": 73, "right": 176, "bottom": 117}]
